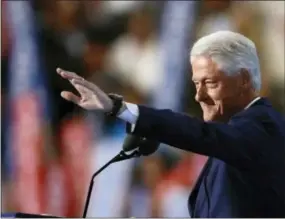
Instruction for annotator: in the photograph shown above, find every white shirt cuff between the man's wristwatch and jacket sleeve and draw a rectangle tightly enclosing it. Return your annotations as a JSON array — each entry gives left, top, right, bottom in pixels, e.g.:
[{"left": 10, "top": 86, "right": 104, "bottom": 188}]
[{"left": 118, "top": 103, "right": 139, "bottom": 132}]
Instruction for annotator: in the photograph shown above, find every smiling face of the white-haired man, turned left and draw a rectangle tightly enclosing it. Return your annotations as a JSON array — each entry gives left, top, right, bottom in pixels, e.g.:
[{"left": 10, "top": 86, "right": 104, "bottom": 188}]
[{"left": 191, "top": 57, "right": 242, "bottom": 122}]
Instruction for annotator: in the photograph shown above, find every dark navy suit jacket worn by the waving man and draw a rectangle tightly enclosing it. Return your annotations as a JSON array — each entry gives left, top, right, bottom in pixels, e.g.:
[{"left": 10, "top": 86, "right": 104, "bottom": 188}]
[{"left": 129, "top": 98, "right": 285, "bottom": 217}]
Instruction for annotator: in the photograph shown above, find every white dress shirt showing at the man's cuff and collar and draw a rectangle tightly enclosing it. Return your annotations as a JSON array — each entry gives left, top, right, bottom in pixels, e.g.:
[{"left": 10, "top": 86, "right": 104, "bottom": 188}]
[{"left": 118, "top": 97, "right": 261, "bottom": 128}]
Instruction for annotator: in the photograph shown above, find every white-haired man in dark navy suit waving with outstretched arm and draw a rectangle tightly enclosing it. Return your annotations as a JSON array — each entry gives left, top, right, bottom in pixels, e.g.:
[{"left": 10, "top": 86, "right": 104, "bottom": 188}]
[{"left": 57, "top": 31, "right": 285, "bottom": 217}]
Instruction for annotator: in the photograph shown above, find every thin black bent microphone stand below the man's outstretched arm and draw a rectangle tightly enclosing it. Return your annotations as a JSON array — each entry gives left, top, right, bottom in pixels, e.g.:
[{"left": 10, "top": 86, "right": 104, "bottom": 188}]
[{"left": 83, "top": 150, "right": 142, "bottom": 218}]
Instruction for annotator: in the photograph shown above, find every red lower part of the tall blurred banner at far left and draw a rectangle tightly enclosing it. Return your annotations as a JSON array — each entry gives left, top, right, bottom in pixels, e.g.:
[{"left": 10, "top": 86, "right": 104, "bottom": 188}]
[{"left": 11, "top": 93, "right": 43, "bottom": 213}]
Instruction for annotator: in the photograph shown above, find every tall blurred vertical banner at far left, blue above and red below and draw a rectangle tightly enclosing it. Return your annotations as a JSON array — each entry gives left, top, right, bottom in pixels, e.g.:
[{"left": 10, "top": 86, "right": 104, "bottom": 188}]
[{"left": 5, "top": 1, "right": 48, "bottom": 213}]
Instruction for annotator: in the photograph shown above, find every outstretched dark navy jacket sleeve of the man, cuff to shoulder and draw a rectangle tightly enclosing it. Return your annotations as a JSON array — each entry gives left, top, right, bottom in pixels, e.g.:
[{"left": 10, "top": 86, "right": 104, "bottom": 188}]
[{"left": 129, "top": 106, "right": 268, "bottom": 168}]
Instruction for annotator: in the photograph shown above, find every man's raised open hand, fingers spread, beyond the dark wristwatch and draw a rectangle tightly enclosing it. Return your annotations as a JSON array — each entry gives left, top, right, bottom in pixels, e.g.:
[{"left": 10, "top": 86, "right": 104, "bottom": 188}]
[{"left": 56, "top": 68, "right": 113, "bottom": 112}]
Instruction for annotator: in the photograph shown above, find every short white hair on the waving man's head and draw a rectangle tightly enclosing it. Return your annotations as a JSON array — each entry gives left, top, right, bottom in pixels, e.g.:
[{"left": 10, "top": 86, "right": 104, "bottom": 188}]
[{"left": 190, "top": 31, "right": 261, "bottom": 91}]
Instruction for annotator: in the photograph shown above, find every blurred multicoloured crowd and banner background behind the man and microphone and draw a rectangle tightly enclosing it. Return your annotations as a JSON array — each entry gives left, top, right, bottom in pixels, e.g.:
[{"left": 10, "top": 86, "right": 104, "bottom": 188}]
[{"left": 1, "top": 0, "right": 285, "bottom": 217}]
